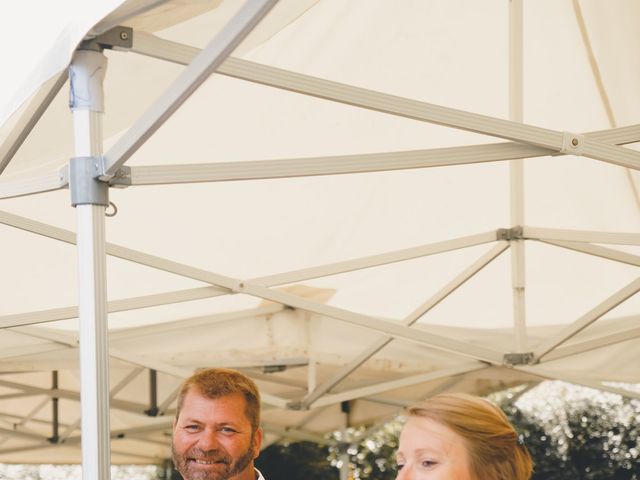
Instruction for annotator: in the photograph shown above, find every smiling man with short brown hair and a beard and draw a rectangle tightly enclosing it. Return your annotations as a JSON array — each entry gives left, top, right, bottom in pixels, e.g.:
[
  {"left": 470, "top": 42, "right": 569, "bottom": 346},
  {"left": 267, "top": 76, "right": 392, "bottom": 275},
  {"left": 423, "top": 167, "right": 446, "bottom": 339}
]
[{"left": 171, "top": 368, "right": 264, "bottom": 480}]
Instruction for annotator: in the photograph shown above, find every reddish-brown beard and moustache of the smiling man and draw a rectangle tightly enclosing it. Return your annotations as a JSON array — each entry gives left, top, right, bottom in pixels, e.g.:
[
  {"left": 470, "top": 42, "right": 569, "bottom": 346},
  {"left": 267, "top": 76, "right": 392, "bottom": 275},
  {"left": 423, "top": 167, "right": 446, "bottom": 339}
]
[{"left": 171, "top": 435, "right": 253, "bottom": 480}]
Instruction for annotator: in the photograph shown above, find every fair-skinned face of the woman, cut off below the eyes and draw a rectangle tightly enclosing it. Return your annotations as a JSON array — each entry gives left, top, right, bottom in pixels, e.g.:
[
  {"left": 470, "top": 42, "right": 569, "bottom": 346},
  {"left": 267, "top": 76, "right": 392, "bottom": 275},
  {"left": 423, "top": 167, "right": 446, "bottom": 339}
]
[{"left": 396, "top": 417, "right": 472, "bottom": 480}]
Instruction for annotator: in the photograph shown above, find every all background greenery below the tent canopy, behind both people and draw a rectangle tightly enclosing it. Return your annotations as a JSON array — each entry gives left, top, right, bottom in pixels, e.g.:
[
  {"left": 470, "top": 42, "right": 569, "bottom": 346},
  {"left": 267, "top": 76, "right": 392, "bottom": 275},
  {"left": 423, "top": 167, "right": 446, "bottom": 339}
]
[{"left": 0, "top": 382, "right": 640, "bottom": 480}]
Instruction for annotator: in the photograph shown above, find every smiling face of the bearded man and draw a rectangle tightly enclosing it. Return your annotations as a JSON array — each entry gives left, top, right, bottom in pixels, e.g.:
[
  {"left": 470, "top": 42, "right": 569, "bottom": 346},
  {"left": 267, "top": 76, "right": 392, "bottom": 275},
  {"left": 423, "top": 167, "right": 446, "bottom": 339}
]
[{"left": 172, "top": 388, "right": 262, "bottom": 480}]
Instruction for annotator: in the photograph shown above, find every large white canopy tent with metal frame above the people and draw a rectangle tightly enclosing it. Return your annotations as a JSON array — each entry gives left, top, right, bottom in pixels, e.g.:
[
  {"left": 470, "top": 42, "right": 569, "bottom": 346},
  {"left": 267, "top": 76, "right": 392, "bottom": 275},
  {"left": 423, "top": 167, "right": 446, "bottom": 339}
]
[{"left": 0, "top": 0, "right": 640, "bottom": 478}]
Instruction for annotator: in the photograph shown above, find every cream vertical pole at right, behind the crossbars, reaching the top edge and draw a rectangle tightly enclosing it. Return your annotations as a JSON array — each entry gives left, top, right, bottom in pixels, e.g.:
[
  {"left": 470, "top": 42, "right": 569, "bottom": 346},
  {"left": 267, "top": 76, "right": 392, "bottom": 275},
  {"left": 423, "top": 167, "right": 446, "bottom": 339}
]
[{"left": 509, "top": 0, "right": 527, "bottom": 353}]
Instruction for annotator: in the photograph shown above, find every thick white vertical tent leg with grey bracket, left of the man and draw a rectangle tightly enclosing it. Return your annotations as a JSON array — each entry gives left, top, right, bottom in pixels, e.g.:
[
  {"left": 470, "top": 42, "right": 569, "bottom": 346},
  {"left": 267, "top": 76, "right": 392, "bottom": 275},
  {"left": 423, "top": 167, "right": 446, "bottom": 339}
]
[{"left": 69, "top": 47, "right": 111, "bottom": 480}]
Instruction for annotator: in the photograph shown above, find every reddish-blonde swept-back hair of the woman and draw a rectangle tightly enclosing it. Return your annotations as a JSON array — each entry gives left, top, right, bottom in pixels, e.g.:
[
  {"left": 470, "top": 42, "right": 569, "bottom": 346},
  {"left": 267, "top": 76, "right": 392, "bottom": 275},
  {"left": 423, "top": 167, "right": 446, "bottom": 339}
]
[{"left": 409, "top": 393, "right": 533, "bottom": 480}]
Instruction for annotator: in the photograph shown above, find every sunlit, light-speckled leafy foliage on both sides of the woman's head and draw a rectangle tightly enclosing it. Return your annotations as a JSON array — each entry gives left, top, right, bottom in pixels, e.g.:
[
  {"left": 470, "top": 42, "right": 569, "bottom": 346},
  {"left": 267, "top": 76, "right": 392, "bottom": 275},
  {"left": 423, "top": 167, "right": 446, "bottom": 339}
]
[{"left": 327, "top": 382, "right": 640, "bottom": 480}]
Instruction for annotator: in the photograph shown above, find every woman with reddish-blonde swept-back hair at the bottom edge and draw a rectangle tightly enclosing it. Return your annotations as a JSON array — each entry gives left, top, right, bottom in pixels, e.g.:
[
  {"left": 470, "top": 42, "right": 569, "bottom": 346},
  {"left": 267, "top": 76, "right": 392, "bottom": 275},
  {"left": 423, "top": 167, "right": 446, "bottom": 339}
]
[{"left": 396, "top": 394, "right": 533, "bottom": 480}]
